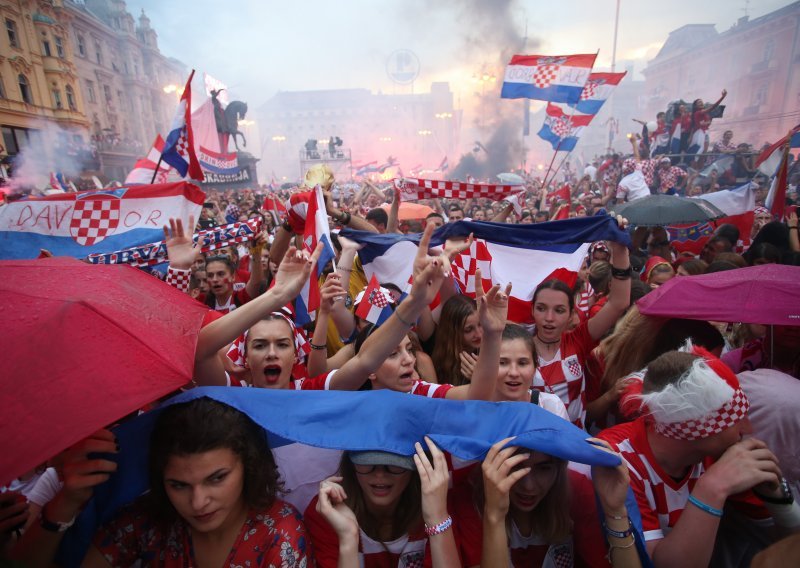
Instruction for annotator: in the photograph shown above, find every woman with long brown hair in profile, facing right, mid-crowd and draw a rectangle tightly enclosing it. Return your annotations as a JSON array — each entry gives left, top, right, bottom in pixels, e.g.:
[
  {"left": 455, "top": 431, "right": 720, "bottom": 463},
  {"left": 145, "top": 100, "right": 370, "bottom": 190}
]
[{"left": 431, "top": 294, "right": 483, "bottom": 386}]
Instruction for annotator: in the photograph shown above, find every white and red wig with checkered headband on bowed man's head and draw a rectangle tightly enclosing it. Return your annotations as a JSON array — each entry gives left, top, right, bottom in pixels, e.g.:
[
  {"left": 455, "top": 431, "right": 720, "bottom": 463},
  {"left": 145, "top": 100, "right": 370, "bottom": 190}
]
[{"left": 625, "top": 347, "right": 750, "bottom": 440}]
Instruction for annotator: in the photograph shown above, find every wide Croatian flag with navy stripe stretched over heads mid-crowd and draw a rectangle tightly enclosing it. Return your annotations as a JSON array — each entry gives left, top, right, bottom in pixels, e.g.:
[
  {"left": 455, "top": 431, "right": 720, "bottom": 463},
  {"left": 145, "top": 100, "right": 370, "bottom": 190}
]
[{"left": 341, "top": 215, "right": 631, "bottom": 323}]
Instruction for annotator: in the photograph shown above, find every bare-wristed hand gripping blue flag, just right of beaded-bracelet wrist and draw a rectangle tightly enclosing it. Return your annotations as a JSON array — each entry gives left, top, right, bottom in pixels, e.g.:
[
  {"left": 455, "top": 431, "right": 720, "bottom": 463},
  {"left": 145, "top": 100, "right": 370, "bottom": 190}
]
[{"left": 481, "top": 437, "right": 531, "bottom": 520}]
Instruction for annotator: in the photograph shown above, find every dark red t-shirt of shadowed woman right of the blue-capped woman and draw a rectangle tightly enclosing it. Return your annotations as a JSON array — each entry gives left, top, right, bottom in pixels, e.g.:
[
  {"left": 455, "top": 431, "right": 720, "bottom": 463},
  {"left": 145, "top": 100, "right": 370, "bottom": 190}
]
[{"left": 450, "top": 470, "right": 609, "bottom": 568}]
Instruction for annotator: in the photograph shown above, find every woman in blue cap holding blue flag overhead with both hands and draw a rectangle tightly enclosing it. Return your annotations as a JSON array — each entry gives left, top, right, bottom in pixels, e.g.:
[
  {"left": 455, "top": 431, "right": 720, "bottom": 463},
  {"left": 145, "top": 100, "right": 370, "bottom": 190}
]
[{"left": 305, "top": 438, "right": 460, "bottom": 568}]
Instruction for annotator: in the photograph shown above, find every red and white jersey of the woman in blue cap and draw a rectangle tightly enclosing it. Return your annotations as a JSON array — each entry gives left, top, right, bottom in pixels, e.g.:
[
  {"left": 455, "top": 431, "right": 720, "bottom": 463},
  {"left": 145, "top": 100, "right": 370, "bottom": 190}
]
[{"left": 303, "top": 497, "right": 432, "bottom": 568}]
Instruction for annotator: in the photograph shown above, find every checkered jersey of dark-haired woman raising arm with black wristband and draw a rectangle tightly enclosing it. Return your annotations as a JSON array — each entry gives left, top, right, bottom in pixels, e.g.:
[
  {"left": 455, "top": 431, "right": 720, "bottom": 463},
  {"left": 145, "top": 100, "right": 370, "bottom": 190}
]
[{"left": 533, "top": 322, "right": 597, "bottom": 428}]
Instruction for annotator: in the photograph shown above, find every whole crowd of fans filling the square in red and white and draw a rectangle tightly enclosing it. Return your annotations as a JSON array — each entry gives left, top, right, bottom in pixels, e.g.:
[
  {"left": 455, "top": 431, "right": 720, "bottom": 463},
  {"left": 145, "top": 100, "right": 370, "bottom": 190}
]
[{"left": 0, "top": 130, "right": 800, "bottom": 567}]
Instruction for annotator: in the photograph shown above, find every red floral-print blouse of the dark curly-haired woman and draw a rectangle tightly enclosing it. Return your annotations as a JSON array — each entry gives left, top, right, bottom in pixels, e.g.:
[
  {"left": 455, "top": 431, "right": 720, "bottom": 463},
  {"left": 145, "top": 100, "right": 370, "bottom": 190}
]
[{"left": 93, "top": 499, "right": 314, "bottom": 568}]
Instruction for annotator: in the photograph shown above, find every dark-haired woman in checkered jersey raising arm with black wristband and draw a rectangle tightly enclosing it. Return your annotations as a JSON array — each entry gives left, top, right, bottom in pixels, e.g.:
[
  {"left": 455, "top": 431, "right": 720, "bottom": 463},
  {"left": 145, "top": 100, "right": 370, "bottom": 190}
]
[{"left": 532, "top": 217, "right": 632, "bottom": 428}]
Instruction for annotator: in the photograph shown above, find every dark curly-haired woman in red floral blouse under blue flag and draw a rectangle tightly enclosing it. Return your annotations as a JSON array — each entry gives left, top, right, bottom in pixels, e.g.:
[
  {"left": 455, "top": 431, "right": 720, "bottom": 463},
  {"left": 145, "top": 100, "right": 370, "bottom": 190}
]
[{"left": 14, "top": 398, "right": 313, "bottom": 567}]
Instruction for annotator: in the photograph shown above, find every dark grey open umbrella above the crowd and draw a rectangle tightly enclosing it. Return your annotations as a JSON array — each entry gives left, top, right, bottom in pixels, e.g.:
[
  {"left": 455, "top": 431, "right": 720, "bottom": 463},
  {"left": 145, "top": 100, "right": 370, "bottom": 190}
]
[{"left": 614, "top": 194, "right": 725, "bottom": 227}]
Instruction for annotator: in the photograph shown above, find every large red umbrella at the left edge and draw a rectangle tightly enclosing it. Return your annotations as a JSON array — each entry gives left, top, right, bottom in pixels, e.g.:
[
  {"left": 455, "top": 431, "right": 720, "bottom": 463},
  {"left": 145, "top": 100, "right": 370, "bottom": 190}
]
[{"left": 0, "top": 257, "right": 208, "bottom": 485}]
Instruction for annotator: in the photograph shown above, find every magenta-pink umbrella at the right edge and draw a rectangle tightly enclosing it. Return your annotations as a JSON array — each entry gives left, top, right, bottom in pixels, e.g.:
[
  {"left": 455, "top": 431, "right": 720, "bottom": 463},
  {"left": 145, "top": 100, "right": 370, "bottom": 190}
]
[{"left": 636, "top": 264, "right": 800, "bottom": 325}]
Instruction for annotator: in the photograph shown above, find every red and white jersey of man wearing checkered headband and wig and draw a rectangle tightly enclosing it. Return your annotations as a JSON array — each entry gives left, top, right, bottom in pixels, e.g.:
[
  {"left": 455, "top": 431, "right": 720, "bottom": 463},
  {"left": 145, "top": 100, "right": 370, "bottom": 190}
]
[{"left": 598, "top": 418, "right": 705, "bottom": 540}]
